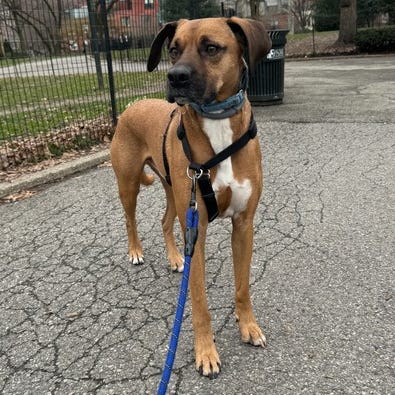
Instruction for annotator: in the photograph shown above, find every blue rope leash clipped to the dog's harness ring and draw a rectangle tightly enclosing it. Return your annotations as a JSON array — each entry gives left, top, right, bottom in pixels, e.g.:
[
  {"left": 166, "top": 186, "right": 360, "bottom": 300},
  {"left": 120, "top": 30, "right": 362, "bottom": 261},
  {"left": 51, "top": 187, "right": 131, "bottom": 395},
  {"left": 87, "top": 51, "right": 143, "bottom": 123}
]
[{"left": 157, "top": 174, "right": 201, "bottom": 395}]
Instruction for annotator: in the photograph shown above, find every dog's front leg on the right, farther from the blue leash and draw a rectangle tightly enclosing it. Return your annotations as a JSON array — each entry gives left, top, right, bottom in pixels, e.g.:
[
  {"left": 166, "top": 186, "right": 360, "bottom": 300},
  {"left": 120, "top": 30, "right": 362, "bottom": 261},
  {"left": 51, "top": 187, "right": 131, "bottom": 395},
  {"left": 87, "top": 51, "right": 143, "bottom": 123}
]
[{"left": 232, "top": 214, "right": 266, "bottom": 347}]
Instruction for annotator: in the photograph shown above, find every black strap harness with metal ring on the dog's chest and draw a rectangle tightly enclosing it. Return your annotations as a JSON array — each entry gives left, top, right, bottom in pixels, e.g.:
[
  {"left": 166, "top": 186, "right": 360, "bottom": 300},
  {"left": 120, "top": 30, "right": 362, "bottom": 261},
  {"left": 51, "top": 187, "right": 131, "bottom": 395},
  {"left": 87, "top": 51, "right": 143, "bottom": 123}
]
[{"left": 162, "top": 110, "right": 257, "bottom": 222}]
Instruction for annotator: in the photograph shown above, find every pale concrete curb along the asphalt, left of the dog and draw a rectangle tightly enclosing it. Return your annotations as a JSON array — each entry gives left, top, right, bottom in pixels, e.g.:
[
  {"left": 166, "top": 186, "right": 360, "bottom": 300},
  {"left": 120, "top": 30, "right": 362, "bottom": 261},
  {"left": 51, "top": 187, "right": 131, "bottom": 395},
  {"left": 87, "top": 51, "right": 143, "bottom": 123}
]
[{"left": 0, "top": 149, "right": 110, "bottom": 198}]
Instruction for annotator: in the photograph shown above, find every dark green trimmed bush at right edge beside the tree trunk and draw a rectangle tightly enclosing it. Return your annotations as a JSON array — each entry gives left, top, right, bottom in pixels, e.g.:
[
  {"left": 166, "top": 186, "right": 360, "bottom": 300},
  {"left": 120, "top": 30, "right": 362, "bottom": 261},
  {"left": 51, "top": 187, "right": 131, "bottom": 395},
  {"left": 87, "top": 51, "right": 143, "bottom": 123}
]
[{"left": 355, "top": 26, "right": 395, "bottom": 53}]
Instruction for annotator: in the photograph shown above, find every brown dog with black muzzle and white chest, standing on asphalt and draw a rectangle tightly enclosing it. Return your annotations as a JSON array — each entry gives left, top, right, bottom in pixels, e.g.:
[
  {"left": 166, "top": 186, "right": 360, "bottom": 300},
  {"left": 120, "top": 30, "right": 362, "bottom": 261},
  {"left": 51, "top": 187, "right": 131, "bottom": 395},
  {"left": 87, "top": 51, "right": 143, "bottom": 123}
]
[{"left": 111, "top": 17, "right": 271, "bottom": 377}]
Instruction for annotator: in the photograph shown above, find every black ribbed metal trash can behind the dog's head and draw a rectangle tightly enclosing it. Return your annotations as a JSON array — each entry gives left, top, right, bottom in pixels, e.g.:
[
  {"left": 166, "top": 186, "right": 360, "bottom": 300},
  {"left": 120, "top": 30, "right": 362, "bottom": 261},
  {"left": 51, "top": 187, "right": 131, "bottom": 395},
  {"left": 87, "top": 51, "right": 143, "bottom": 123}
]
[{"left": 247, "top": 29, "right": 289, "bottom": 106}]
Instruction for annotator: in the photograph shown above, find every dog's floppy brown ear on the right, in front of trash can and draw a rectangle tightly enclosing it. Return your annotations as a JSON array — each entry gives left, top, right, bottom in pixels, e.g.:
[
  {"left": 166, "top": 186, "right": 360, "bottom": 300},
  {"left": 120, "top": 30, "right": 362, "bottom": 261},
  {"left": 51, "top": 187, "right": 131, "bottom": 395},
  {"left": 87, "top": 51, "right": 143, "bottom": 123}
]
[{"left": 227, "top": 16, "right": 272, "bottom": 69}]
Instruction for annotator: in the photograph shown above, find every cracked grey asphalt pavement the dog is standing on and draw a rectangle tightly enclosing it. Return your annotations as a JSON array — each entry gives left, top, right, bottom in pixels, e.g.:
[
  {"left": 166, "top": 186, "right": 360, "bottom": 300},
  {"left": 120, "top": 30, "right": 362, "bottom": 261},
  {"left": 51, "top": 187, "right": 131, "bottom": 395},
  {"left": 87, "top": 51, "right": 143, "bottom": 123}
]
[{"left": 0, "top": 56, "right": 395, "bottom": 395}]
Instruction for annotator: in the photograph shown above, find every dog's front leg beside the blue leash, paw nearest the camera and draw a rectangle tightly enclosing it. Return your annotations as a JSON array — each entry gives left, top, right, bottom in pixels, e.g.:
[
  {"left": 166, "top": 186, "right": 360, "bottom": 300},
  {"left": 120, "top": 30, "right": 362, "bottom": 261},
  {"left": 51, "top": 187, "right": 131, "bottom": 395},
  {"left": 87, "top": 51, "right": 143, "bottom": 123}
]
[{"left": 190, "top": 227, "right": 221, "bottom": 378}]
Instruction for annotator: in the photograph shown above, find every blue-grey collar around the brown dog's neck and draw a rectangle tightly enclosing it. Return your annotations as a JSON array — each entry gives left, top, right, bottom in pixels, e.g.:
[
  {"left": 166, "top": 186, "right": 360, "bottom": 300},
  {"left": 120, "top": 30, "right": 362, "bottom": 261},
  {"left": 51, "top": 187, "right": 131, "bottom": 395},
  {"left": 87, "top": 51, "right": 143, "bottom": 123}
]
[{"left": 189, "top": 58, "right": 248, "bottom": 119}]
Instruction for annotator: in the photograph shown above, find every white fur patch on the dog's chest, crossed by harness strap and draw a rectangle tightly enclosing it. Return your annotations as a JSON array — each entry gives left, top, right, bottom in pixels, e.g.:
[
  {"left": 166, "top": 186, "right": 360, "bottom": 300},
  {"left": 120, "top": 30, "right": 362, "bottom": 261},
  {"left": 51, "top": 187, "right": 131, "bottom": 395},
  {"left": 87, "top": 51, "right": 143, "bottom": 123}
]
[{"left": 203, "top": 118, "right": 252, "bottom": 217}]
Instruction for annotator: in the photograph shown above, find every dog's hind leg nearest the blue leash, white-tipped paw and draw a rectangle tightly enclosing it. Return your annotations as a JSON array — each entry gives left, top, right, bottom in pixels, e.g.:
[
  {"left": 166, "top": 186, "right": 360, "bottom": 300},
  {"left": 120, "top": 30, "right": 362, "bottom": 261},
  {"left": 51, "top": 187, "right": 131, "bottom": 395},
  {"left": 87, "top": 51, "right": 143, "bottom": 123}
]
[{"left": 162, "top": 181, "right": 184, "bottom": 272}]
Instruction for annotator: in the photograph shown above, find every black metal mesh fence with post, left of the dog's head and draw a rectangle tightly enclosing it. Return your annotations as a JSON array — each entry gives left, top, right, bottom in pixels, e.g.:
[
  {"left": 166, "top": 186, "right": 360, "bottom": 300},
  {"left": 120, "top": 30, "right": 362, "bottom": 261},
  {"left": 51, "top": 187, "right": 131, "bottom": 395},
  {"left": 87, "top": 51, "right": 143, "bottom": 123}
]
[{"left": 0, "top": 0, "right": 196, "bottom": 171}]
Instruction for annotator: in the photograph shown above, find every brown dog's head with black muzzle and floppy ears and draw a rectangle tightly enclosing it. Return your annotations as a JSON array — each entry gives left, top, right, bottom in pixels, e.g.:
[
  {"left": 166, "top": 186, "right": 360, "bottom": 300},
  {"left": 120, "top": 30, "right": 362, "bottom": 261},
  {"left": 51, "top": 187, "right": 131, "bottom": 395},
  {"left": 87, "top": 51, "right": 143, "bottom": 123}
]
[{"left": 147, "top": 17, "right": 271, "bottom": 104}]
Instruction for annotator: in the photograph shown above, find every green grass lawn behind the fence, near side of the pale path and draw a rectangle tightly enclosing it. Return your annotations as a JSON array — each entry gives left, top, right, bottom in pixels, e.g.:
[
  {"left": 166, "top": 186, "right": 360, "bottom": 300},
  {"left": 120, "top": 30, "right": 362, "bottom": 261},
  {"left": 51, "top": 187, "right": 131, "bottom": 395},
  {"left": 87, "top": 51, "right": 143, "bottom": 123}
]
[{"left": 0, "top": 72, "right": 165, "bottom": 140}]
